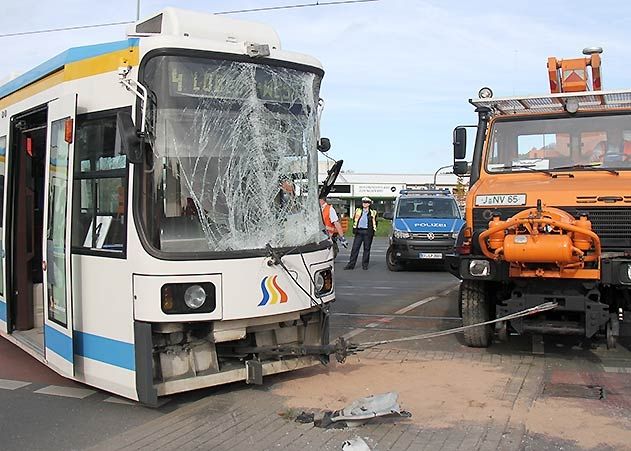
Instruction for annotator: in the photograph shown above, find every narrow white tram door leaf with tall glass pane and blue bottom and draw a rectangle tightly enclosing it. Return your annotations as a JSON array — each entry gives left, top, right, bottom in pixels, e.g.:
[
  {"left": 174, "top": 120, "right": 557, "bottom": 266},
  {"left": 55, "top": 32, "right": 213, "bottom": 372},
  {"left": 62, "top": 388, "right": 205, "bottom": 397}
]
[{"left": 42, "top": 94, "right": 77, "bottom": 376}]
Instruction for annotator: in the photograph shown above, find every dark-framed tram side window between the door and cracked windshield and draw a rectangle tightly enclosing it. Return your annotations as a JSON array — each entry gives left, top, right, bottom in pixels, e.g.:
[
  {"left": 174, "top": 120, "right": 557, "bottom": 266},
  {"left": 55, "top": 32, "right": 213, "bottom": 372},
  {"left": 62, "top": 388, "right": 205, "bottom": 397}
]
[{"left": 72, "top": 111, "right": 127, "bottom": 255}]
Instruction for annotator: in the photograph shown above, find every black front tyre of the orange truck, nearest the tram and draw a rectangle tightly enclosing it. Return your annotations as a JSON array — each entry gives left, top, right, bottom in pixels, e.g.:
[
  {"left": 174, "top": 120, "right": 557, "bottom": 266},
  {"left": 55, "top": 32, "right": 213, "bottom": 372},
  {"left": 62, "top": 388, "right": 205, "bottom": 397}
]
[{"left": 460, "top": 280, "right": 493, "bottom": 348}]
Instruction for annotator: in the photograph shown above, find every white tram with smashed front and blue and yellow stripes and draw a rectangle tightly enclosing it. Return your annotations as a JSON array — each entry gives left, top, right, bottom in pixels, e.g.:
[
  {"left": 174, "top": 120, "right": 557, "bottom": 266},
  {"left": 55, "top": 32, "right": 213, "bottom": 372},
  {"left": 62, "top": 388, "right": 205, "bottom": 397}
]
[{"left": 0, "top": 8, "right": 339, "bottom": 405}]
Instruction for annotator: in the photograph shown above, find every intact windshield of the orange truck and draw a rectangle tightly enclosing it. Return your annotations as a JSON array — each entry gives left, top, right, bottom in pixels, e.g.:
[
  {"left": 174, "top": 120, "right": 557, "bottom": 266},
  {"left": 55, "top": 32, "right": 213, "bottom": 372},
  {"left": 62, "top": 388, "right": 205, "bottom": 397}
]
[{"left": 486, "top": 115, "right": 631, "bottom": 172}]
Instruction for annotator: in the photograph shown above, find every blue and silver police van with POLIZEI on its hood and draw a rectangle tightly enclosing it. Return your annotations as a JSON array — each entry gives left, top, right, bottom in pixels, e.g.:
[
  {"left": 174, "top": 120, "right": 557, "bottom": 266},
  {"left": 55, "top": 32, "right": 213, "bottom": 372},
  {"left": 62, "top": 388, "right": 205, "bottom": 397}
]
[{"left": 383, "top": 189, "right": 464, "bottom": 271}]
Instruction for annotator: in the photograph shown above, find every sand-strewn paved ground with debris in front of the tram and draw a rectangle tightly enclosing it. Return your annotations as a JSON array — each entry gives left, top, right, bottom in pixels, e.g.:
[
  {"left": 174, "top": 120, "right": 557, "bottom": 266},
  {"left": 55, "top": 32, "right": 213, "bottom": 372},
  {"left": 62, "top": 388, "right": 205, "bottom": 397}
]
[{"left": 94, "top": 350, "right": 631, "bottom": 451}]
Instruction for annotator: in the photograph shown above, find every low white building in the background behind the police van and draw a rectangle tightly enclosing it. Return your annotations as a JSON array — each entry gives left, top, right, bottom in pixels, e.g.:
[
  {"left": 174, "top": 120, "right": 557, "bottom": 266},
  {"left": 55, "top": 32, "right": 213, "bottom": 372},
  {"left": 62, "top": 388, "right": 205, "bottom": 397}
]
[{"left": 318, "top": 161, "right": 468, "bottom": 220}]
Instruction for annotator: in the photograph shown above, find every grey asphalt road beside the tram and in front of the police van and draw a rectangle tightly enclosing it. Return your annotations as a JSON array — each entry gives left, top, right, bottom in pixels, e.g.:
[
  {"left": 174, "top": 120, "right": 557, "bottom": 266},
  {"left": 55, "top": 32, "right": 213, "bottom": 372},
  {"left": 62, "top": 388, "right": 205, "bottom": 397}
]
[{"left": 0, "top": 239, "right": 631, "bottom": 451}]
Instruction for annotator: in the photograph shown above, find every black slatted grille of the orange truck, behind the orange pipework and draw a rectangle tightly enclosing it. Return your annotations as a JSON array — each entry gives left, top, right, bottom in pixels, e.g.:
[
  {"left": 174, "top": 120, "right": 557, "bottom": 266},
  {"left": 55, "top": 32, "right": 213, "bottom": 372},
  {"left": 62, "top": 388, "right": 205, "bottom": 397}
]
[{"left": 473, "top": 207, "right": 631, "bottom": 251}]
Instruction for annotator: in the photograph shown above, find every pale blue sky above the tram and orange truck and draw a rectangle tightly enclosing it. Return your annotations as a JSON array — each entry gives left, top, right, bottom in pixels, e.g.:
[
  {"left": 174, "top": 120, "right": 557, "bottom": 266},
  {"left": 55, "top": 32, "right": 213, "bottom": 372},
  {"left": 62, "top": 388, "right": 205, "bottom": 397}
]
[{"left": 0, "top": 0, "right": 631, "bottom": 174}]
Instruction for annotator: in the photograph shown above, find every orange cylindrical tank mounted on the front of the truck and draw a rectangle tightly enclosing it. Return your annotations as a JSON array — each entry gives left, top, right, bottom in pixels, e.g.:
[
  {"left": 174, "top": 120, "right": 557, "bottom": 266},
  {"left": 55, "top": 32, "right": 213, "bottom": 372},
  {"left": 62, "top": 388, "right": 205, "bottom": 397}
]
[{"left": 504, "top": 235, "right": 578, "bottom": 264}]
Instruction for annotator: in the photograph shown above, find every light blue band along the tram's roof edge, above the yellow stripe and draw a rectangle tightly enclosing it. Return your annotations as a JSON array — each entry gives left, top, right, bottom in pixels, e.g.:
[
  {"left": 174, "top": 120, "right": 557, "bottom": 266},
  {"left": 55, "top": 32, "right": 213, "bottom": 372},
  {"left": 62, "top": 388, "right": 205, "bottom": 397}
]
[{"left": 0, "top": 38, "right": 139, "bottom": 99}]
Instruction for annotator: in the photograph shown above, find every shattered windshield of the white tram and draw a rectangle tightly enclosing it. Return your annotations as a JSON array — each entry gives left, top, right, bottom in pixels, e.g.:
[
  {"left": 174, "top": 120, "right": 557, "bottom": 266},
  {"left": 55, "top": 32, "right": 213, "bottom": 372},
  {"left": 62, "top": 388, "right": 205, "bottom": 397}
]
[{"left": 141, "top": 56, "right": 326, "bottom": 253}]
